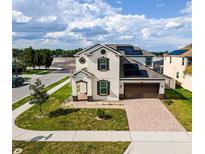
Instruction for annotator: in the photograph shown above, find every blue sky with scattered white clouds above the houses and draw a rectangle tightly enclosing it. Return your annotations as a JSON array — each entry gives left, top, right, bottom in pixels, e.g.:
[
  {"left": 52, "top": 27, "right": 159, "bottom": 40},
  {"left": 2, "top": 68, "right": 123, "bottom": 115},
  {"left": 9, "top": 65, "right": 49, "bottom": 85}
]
[{"left": 12, "top": 0, "right": 192, "bottom": 52}]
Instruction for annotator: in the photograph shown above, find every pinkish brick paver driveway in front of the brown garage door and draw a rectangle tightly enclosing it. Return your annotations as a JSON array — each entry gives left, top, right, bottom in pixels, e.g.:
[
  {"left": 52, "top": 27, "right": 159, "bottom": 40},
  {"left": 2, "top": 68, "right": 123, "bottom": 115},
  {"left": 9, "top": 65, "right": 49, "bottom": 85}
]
[{"left": 124, "top": 99, "right": 185, "bottom": 131}]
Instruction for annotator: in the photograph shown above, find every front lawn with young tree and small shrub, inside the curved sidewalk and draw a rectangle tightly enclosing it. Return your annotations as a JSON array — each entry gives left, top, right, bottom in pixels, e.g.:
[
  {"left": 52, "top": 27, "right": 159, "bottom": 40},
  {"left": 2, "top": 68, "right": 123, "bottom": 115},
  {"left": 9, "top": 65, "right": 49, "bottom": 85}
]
[{"left": 16, "top": 85, "right": 129, "bottom": 130}]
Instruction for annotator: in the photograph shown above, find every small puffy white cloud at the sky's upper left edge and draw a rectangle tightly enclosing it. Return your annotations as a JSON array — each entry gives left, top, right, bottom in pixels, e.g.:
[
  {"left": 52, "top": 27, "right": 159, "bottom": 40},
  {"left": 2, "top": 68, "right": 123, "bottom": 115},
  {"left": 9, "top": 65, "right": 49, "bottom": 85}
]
[{"left": 12, "top": 10, "right": 32, "bottom": 23}]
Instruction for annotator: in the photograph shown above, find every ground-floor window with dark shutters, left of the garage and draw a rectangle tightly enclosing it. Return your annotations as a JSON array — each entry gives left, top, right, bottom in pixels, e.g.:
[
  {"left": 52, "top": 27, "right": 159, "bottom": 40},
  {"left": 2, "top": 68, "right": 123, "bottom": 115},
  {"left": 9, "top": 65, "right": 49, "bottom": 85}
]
[{"left": 97, "top": 80, "right": 110, "bottom": 96}]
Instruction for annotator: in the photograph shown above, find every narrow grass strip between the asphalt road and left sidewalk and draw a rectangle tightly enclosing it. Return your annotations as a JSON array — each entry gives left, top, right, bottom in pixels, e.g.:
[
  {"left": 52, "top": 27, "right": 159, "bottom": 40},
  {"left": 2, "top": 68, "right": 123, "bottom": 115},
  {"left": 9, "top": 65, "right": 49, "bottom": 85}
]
[{"left": 12, "top": 77, "right": 69, "bottom": 110}]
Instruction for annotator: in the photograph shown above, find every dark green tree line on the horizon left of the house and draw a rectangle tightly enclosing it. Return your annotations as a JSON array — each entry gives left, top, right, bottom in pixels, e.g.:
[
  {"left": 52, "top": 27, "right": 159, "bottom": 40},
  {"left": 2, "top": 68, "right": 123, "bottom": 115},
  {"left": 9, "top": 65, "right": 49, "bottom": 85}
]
[{"left": 13, "top": 47, "right": 82, "bottom": 69}]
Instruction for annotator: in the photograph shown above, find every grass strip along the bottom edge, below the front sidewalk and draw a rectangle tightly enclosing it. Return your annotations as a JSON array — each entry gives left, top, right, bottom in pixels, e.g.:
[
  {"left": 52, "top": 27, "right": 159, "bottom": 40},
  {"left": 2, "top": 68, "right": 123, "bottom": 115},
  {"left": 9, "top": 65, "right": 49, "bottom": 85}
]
[{"left": 12, "top": 141, "right": 130, "bottom": 154}]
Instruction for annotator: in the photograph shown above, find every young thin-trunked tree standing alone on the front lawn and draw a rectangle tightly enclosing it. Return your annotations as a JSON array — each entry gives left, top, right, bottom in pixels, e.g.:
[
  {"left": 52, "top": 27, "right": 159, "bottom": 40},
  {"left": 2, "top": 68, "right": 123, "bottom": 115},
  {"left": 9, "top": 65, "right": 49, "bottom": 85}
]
[{"left": 29, "top": 79, "right": 49, "bottom": 116}]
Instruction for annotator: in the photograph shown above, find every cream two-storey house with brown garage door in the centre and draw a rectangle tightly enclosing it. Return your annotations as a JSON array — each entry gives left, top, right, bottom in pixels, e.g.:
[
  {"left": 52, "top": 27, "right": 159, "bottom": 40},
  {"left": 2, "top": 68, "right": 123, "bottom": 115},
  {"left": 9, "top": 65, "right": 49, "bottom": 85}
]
[{"left": 71, "top": 44, "right": 165, "bottom": 101}]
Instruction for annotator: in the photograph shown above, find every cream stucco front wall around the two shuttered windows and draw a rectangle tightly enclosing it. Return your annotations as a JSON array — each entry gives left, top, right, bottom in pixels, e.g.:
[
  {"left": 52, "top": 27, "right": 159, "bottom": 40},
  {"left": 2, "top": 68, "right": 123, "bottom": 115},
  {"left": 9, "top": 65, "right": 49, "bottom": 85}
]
[{"left": 76, "top": 46, "right": 120, "bottom": 100}]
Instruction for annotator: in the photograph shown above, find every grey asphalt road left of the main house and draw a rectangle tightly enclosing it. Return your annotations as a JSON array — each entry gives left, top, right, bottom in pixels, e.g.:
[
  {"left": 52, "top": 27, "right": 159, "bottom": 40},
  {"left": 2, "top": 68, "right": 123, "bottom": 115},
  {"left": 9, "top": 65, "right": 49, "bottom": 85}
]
[{"left": 12, "top": 58, "right": 75, "bottom": 103}]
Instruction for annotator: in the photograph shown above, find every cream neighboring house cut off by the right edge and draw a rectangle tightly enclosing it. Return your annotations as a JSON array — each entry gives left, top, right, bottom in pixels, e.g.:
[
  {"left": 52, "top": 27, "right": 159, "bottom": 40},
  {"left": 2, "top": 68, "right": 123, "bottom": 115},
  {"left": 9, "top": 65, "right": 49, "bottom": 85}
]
[{"left": 163, "top": 44, "right": 192, "bottom": 91}]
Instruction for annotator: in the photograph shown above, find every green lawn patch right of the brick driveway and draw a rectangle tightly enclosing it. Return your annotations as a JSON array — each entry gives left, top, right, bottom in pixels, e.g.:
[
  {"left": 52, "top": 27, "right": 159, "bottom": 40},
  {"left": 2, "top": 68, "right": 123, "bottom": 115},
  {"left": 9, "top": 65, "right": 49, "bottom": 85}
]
[{"left": 164, "top": 88, "right": 192, "bottom": 131}]
